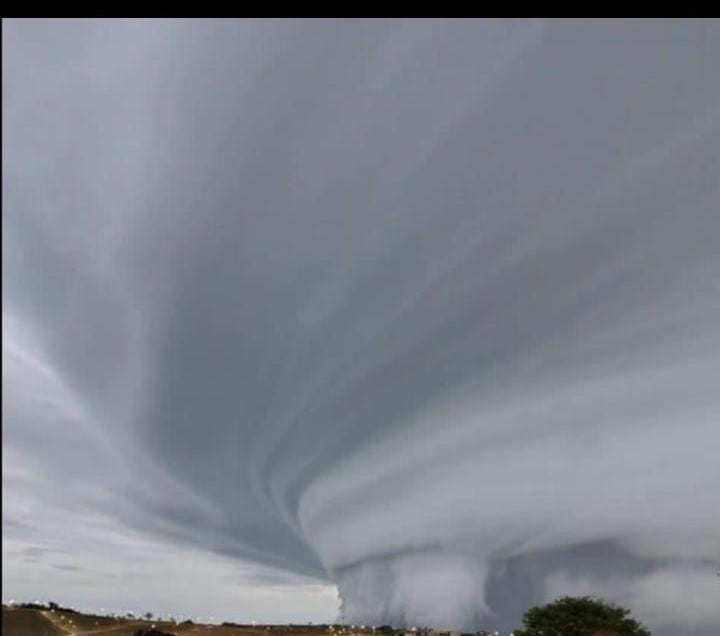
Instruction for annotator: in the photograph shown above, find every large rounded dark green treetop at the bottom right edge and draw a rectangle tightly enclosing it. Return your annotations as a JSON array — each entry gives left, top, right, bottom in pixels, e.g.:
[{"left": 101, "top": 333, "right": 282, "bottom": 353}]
[{"left": 513, "top": 596, "right": 650, "bottom": 636}]
